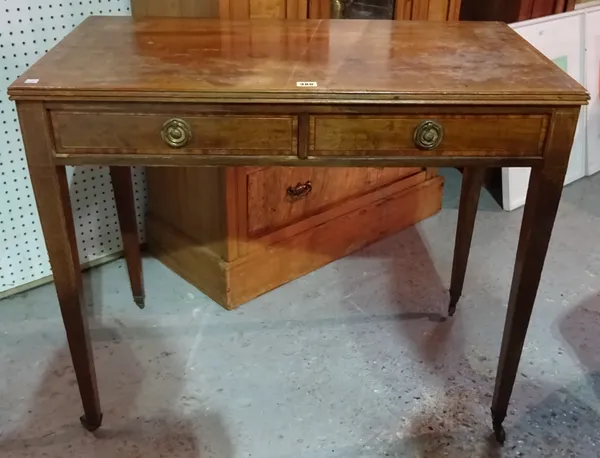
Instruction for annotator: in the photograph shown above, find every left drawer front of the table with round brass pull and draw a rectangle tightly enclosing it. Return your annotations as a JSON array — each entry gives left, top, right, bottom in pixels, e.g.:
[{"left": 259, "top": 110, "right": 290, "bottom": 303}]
[{"left": 51, "top": 111, "right": 297, "bottom": 156}]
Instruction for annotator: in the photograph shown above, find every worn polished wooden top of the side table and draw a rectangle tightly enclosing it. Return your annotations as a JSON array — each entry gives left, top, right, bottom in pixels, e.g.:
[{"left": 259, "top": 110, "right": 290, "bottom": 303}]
[{"left": 9, "top": 16, "right": 588, "bottom": 104}]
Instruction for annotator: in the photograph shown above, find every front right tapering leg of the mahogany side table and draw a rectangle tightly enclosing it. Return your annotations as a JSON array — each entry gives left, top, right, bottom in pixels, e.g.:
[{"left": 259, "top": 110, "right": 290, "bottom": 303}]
[{"left": 492, "top": 108, "right": 579, "bottom": 442}]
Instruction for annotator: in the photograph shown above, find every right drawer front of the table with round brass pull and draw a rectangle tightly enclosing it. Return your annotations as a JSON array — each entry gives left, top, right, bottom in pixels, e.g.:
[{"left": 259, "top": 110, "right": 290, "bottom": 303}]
[{"left": 309, "top": 114, "right": 548, "bottom": 156}]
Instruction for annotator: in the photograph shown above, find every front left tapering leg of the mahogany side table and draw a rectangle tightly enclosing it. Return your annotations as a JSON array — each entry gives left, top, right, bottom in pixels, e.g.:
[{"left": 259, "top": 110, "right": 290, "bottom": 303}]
[{"left": 18, "top": 102, "right": 102, "bottom": 431}]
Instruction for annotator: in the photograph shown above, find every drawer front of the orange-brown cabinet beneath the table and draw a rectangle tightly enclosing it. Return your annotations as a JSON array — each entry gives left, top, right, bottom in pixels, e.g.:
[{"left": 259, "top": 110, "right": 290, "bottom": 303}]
[{"left": 246, "top": 167, "right": 421, "bottom": 237}]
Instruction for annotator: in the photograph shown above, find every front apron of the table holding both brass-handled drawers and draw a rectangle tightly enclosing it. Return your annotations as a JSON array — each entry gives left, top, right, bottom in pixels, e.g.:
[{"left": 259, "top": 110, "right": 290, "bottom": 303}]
[{"left": 44, "top": 102, "right": 554, "bottom": 167}]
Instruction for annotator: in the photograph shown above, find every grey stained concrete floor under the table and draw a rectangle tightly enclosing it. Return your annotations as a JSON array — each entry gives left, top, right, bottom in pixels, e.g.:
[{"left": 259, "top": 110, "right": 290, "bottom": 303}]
[{"left": 0, "top": 171, "right": 600, "bottom": 458}]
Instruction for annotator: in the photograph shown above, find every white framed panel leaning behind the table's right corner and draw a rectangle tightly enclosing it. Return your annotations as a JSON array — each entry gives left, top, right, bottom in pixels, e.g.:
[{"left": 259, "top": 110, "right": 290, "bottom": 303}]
[{"left": 502, "top": 13, "right": 586, "bottom": 211}]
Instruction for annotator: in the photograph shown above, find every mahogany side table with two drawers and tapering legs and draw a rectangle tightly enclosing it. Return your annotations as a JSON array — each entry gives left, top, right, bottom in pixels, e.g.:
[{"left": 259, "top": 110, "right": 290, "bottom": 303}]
[{"left": 9, "top": 17, "right": 588, "bottom": 441}]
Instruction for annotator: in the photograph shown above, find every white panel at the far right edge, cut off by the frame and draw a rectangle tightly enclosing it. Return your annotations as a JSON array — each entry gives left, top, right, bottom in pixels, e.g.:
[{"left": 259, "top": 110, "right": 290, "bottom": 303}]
[{"left": 585, "top": 10, "right": 600, "bottom": 175}]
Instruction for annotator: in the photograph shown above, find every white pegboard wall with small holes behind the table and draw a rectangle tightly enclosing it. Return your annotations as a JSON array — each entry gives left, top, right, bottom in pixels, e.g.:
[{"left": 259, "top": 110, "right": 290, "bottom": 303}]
[{"left": 0, "top": 0, "right": 146, "bottom": 295}]
